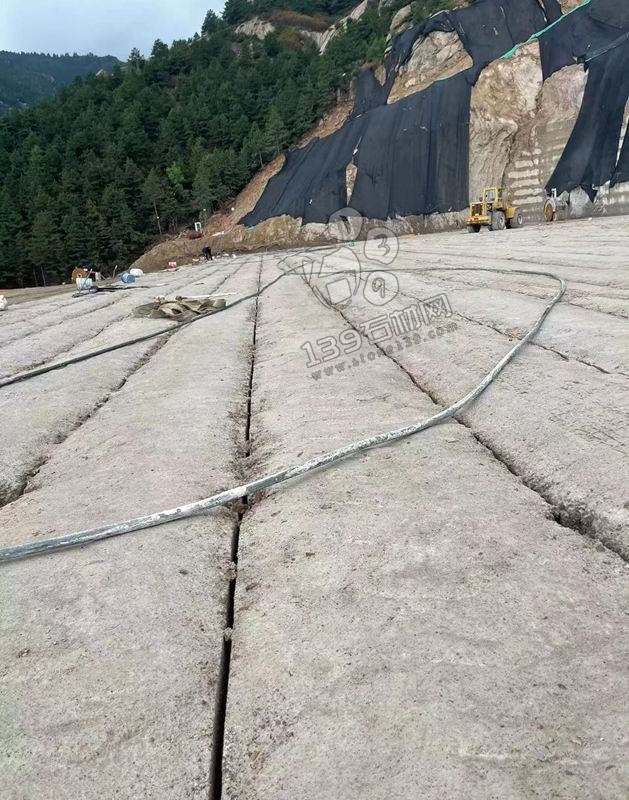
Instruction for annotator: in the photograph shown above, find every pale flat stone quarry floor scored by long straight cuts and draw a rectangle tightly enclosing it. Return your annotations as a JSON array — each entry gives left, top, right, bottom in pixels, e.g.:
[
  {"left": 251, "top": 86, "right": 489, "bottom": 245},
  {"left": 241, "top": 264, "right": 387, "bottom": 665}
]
[{"left": 0, "top": 217, "right": 629, "bottom": 800}]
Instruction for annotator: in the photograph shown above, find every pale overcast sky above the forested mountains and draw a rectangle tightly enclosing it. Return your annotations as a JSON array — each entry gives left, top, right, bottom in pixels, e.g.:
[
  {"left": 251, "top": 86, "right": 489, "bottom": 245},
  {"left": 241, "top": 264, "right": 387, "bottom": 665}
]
[{"left": 0, "top": 0, "right": 224, "bottom": 59}]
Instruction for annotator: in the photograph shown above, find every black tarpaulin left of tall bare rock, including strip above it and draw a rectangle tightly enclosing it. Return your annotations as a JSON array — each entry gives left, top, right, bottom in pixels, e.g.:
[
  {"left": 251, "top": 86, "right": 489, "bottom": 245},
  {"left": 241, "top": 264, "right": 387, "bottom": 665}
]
[{"left": 241, "top": 0, "right": 561, "bottom": 225}]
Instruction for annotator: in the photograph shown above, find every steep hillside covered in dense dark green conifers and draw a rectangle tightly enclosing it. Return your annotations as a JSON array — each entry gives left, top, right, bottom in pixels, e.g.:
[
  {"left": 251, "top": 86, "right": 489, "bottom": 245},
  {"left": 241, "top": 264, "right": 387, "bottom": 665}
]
[{"left": 0, "top": 3, "right": 392, "bottom": 287}]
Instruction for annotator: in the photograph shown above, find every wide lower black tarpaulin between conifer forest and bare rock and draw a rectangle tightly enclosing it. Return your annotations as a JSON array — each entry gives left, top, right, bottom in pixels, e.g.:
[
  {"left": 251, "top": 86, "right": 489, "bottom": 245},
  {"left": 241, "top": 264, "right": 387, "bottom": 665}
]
[{"left": 241, "top": 73, "right": 471, "bottom": 225}]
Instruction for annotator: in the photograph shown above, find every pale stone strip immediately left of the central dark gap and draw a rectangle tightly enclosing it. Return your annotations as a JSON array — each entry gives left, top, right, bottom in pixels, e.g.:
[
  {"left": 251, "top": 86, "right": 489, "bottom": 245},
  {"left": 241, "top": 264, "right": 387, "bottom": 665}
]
[{"left": 0, "top": 269, "right": 257, "bottom": 800}]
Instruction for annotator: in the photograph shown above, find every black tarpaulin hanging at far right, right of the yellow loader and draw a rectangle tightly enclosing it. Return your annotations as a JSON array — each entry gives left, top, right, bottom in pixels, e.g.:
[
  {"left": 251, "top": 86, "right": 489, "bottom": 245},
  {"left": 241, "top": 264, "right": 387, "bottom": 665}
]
[{"left": 546, "top": 41, "right": 629, "bottom": 199}]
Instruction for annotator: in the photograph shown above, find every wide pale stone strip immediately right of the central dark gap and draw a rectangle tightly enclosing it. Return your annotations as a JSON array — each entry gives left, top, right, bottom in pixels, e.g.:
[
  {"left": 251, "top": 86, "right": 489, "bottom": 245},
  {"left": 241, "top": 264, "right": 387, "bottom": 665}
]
[{"left": 223, "top": 244, "right": 629, "bottom": 800}]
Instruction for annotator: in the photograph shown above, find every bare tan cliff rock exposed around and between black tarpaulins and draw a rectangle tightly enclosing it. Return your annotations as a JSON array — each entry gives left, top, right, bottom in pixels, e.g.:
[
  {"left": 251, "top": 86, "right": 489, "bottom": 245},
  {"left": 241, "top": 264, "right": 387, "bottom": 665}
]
[{"left": 138, "top": 0, "right": 629, "bottom": 268}]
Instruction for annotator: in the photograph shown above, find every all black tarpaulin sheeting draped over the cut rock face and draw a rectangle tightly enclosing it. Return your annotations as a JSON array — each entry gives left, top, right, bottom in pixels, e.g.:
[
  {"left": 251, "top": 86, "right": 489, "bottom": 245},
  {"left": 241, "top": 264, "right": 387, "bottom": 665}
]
[{"left": 241, "top": 0, "right": 629, "bottom": 231}]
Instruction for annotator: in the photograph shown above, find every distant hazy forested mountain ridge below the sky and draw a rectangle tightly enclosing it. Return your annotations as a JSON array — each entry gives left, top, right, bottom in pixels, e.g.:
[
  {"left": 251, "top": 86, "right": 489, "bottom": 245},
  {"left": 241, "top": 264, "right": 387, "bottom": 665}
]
[{"left": 0, "top": 50, "right": 122, "bottom": 115}]
